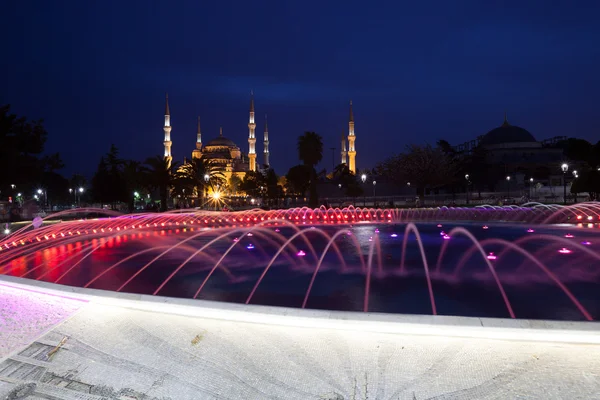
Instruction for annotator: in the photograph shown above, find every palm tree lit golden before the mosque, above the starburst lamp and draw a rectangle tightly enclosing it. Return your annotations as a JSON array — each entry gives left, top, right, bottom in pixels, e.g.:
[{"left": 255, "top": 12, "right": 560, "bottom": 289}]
[{"left": 176, "top": 158, "right": 227, "bottom": 206}]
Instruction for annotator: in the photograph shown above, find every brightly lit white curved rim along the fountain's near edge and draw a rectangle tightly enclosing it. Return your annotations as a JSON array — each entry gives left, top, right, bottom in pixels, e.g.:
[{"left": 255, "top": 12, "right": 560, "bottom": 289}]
[{"left": 0, "top": 275, "right": 600, "bottom": 344}]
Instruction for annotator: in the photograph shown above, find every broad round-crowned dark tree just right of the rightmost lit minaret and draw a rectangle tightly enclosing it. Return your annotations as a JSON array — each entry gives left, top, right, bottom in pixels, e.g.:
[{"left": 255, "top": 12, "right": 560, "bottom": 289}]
[{"left": 377, "top": 145, "right": 457, "bottom": 202}]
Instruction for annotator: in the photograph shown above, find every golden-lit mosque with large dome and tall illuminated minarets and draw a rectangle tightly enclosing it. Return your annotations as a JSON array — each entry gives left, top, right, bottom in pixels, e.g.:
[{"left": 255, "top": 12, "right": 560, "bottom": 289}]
[{"left": 163, "top": 92, "right": 356, "bottom": 193}]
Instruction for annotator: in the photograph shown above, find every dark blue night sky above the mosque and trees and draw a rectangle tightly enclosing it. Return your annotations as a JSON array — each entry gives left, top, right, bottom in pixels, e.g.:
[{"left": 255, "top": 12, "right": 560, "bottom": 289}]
[{"left": 0, "top": 0, "right": 600, "bottom": 174}]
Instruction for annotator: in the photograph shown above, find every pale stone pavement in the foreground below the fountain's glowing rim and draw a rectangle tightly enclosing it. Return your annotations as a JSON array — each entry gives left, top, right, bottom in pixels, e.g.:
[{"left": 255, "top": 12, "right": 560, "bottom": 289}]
[{"left": 0, "top": 285, "right": 600, "bottom": 400}]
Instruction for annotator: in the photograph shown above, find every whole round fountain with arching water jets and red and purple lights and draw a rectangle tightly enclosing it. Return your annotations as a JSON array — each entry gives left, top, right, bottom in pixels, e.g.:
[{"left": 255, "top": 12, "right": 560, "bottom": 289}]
[{"left": 0, "top": 203, "right": 600, "bottom": 320}]
